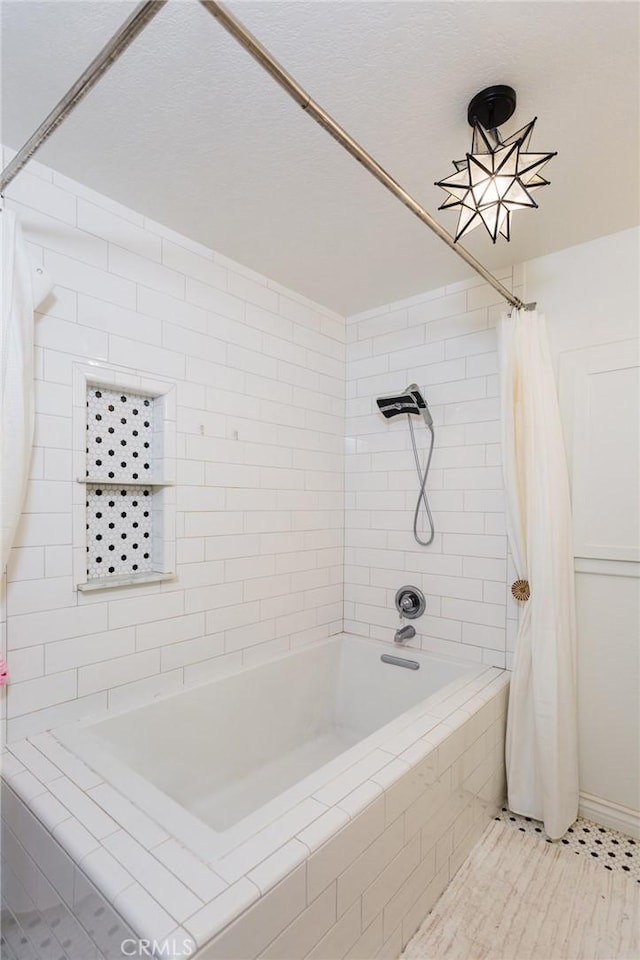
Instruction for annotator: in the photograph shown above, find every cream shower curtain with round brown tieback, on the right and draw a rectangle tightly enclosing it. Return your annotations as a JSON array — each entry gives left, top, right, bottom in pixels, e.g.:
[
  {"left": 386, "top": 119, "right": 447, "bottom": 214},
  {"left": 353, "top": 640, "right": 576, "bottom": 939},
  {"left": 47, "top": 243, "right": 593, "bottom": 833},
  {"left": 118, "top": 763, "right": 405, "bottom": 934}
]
[{"left": 498, "top": 310, "right": 578, "bottom": 839}]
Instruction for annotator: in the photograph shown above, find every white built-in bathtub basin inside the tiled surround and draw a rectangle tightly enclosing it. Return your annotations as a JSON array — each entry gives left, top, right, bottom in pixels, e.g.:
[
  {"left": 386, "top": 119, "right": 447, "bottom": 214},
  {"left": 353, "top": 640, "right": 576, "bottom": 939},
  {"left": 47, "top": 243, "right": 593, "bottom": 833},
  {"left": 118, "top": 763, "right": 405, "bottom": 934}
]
[{"left": 58, "top": 637, "right": 477, "bottom": 853}]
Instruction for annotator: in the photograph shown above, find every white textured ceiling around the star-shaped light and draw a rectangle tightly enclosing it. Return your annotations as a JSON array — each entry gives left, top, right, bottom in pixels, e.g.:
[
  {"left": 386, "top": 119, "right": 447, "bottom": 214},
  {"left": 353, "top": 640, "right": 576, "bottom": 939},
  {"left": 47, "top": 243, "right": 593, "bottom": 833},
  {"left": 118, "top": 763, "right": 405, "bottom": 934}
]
[{"left": 2, "top": 0, "right": 639, "bottom": 314}]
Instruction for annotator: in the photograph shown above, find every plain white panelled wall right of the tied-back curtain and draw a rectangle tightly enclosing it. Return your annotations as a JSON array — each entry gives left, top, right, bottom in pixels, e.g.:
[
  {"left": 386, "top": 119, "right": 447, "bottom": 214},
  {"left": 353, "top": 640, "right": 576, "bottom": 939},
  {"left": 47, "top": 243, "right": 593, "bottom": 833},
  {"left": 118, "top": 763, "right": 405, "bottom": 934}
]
[{"left": 526, "top": 229, "right": 640, "bottom": 831}]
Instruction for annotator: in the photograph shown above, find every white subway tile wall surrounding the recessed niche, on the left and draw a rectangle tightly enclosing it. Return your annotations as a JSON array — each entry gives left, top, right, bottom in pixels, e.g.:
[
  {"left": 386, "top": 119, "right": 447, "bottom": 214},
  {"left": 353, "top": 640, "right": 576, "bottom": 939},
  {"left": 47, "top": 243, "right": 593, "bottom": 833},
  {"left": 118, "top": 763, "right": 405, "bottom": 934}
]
[{"left": 0, "top": 154, "right": 345, "bottom": 737}]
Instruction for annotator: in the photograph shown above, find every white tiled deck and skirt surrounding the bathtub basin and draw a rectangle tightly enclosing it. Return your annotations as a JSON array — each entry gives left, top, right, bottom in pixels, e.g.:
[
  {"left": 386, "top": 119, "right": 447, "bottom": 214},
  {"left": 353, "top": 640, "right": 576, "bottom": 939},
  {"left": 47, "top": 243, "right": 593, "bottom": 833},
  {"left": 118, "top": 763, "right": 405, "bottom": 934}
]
[{"left": 2, "top": 669, "right": 509, "bottom": 960}]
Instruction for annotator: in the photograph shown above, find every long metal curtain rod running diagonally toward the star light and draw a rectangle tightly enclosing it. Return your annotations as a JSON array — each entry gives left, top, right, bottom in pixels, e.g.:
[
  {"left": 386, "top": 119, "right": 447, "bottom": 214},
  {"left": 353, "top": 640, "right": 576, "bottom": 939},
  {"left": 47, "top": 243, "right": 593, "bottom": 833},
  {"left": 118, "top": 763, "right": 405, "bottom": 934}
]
[{"left": 200, "top": 0, "right": 526, "bottom": 309}]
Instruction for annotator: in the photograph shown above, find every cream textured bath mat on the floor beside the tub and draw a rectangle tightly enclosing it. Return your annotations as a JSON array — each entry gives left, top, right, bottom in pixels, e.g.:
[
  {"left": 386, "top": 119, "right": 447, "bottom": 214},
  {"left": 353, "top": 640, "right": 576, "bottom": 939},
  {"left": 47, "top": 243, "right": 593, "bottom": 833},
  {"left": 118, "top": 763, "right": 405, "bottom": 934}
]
[{"left": 402, "top": 810, "right": 640, "bottom": 960}]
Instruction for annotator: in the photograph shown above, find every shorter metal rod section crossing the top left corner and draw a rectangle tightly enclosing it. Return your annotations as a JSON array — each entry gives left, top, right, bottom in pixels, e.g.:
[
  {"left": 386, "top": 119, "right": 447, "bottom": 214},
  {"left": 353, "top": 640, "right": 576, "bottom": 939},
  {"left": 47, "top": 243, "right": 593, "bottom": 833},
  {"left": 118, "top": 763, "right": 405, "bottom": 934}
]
[{"left": 0, "top": 0, "right": 167, "bottom": 193}]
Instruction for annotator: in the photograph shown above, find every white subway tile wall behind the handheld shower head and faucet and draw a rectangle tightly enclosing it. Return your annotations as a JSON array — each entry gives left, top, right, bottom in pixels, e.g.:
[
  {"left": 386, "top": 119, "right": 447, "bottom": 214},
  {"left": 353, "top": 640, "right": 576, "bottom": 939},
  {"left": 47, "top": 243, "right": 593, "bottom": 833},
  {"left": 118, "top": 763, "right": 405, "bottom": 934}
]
[{"left": 345, "top": 269, "right": 523, "bottom": 667}]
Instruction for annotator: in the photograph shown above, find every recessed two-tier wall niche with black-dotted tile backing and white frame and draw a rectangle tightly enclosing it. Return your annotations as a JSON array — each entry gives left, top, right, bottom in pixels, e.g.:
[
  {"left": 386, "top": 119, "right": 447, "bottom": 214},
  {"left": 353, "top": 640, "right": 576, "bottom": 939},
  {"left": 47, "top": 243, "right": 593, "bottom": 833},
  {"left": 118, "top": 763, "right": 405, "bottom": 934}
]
[{"left": 74, "top": 366, "right": 175, "bottom": 593}]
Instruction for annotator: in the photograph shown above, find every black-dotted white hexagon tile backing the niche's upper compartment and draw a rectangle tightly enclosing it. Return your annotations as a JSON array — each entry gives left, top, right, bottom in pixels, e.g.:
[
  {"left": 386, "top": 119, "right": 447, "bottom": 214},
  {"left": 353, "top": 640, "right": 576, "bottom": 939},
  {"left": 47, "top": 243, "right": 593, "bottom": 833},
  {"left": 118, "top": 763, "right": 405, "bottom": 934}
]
[{"left": 86, "top": 385, "right": 153, "bottom": 483}]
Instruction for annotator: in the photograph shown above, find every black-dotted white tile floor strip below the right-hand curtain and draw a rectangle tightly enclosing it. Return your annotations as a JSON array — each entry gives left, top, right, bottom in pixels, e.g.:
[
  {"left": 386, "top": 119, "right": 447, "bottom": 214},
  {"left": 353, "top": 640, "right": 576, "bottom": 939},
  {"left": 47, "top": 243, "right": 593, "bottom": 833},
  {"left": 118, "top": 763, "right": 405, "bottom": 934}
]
[{"left": 496, "top": 807, "right": 640, "bottom": 883}]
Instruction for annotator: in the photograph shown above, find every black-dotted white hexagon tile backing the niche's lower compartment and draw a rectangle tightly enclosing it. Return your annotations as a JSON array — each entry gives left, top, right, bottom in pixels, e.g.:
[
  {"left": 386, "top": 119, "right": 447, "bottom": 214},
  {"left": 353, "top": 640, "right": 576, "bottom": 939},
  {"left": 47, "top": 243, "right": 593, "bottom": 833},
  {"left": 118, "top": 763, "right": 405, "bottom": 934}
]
[{"left": 87, "top": 483, "right": 153, "bottom": 580}]
